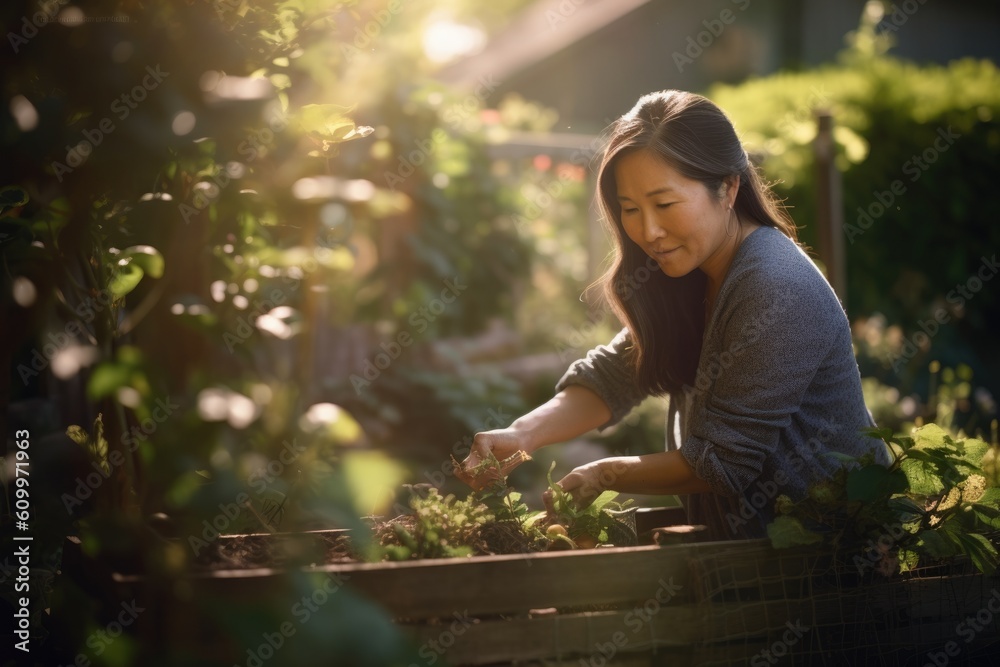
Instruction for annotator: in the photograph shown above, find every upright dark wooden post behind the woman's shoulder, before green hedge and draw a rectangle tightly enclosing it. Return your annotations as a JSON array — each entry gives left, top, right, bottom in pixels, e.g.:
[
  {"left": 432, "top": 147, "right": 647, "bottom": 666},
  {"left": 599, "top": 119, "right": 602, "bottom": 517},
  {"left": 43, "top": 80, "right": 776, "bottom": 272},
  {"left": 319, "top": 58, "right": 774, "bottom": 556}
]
[{"left": 813, "top": 110, "right": 847, "bottom": 309}]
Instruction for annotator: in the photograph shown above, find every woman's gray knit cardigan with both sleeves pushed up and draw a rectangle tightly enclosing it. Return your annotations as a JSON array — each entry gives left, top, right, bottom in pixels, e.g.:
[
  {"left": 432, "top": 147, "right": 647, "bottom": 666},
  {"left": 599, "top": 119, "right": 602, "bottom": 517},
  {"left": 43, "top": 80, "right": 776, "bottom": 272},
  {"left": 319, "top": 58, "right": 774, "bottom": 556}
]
[{"left": 556, "top": 227, "right": 889, "bottom": 539}]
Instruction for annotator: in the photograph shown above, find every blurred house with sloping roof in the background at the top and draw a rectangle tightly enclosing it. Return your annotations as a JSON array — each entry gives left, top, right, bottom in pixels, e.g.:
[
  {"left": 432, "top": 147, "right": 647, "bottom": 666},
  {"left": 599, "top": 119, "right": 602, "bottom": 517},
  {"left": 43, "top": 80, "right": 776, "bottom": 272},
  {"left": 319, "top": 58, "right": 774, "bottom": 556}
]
[{"left": 439, "top": 0, "right": 1000, "bottom": 133}]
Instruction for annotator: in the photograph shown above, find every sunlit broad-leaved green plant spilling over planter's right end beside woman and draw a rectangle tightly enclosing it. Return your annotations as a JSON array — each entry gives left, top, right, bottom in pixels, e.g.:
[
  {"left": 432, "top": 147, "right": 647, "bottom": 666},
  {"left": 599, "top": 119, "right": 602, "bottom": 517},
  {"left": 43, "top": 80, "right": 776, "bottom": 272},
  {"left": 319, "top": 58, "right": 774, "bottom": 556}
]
[{"left": 767, "top": 424, "right": 1000, "bottom": 576}]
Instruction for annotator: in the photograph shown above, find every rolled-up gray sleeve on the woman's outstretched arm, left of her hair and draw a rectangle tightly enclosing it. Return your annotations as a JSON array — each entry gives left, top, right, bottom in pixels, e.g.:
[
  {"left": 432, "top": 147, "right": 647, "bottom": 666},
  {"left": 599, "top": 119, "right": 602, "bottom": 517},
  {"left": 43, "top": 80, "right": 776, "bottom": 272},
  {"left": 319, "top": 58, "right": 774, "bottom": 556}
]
[{"left": 556, "top": 329, "right": 647, "bottom": 431}]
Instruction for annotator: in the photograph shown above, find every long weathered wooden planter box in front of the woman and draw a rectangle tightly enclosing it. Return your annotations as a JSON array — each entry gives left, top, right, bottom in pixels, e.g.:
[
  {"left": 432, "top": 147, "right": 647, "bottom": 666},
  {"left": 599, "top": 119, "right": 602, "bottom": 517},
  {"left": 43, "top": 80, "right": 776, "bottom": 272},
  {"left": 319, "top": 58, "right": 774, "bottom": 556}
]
[{"left": 60, "top": 512, "right": 1000, "bottom": 667}]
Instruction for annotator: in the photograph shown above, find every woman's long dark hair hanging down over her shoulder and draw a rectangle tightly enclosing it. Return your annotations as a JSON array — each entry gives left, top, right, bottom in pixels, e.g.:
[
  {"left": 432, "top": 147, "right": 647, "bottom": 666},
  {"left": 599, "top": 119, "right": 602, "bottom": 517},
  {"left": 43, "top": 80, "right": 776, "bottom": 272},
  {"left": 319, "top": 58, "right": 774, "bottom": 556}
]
[{"left": 597, "top": 90, "right": 797, "bottom": 394}]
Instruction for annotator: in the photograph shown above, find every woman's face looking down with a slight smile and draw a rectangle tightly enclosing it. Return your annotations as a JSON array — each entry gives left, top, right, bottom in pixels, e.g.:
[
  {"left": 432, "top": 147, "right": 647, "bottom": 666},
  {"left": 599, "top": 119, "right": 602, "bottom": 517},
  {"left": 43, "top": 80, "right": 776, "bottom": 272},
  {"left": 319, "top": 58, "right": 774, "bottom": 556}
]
[{"left": 615, "top": 149, "right": 735, "bottom": 285}]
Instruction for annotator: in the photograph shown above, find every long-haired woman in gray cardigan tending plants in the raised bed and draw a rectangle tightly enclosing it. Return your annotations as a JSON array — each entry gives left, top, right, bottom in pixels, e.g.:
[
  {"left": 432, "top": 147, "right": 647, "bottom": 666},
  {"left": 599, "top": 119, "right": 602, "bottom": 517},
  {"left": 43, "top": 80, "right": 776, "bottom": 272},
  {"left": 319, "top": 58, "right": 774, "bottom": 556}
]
[{"left": 465, "top": 90, "right": 889, "bottom": 539}]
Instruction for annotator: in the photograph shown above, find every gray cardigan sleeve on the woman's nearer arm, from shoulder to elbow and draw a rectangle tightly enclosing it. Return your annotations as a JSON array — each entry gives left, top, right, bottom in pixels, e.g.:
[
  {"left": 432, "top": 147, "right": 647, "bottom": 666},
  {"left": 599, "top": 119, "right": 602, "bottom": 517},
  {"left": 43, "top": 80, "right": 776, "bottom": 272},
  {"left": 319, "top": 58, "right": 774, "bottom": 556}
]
[{"left": 681, "top": 272, "right": 845, "bottom": 496}]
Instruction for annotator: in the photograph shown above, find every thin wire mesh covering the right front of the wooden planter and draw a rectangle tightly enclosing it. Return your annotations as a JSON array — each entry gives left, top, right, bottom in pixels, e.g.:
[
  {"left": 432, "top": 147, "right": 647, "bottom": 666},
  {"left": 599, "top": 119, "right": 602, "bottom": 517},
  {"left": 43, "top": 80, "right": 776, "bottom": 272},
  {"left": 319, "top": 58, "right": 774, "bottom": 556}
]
[{"left": 690, "top": 545, "right": 1000, "bottom": 667}]
